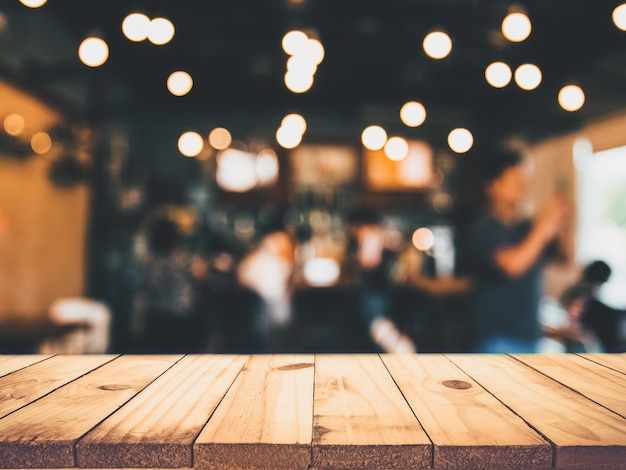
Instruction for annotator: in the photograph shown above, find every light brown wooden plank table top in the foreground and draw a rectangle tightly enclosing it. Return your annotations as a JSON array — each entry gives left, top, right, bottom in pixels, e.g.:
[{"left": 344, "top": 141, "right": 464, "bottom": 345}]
[{"left": 0, "top": 354, "right": 626, "bottom": 470}]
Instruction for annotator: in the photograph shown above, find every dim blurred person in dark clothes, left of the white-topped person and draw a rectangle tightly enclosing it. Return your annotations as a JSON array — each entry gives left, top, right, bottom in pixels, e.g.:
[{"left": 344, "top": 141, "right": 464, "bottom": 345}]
[{"left": 135, "top": 216, "right": 206, "bottom": 353}]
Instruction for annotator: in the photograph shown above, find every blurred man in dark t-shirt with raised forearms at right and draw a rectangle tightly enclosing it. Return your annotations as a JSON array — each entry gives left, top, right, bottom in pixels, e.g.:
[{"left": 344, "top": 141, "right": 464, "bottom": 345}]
[{"left": 468, "top": 150, "right": 569, "bottom": 353}]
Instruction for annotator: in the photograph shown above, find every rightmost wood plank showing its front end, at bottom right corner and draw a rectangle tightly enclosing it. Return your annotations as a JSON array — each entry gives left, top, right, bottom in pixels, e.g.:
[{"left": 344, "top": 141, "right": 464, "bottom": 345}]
[{"left": 448, "top": 355, "right": 626, "bottom": 470}]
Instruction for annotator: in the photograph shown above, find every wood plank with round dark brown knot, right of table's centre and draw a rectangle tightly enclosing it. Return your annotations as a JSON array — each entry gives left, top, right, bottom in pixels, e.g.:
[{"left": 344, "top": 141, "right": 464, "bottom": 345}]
[{"left": 381, "top": 354, "right": 552, "bottom": 470}]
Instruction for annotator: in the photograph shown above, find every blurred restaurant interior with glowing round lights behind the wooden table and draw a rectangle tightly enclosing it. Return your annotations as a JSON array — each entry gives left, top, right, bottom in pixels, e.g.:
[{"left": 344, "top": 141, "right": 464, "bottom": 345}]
[{"left": 0, "top": 0, "right": 626, "bottom": 353}]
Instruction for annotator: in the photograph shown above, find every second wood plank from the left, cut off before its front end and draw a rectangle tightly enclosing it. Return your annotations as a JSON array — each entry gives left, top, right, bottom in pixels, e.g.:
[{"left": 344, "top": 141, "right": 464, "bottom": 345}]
[{"left": 0, "top": 354, "right": 116, "bottom": 418}]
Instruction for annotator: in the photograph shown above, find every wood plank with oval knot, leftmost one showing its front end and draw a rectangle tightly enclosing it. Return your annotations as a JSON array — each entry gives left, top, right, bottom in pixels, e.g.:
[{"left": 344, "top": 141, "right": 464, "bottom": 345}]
[{"left": 0, "top": 356, "right": 181, "bottom": 468}]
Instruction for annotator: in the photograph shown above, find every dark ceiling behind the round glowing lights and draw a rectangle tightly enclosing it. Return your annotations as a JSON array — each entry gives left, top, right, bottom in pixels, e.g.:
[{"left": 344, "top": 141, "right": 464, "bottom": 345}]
[{"left": 6, "top": 0, "right": 626, "bottom": 150}]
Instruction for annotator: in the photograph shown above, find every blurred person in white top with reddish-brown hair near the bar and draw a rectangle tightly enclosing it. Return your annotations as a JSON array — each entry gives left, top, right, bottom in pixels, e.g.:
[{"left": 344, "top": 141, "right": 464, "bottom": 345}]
[{"left": 237, "top": 228, "right": 295, "bottom": 352}]
